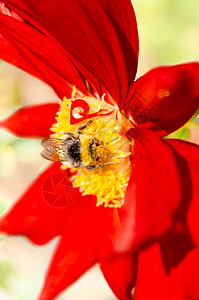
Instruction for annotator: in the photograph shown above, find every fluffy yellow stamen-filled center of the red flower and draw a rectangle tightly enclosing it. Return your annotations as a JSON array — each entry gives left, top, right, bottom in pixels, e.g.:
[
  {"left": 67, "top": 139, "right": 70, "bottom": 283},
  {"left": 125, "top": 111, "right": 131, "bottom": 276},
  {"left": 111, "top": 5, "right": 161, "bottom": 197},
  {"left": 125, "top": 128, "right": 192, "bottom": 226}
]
[{"left": 51, "top": 90, "right": 131, "bottom": 207}]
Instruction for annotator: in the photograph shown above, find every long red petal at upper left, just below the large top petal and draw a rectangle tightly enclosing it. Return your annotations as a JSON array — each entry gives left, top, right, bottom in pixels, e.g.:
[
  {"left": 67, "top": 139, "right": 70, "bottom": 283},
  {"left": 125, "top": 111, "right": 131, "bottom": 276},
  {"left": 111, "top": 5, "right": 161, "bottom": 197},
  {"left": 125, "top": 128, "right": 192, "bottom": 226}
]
[{"left": 0, "top": 7, "right": 87, "bottom": 98}]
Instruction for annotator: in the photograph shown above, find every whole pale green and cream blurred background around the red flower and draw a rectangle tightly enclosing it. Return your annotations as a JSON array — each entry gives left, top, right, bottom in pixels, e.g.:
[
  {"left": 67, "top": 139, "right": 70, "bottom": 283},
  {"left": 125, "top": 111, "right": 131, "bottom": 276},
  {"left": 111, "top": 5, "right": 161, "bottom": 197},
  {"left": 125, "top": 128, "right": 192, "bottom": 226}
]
[{"left": 0, "top": 0, "right": 199, "bottom": 300}]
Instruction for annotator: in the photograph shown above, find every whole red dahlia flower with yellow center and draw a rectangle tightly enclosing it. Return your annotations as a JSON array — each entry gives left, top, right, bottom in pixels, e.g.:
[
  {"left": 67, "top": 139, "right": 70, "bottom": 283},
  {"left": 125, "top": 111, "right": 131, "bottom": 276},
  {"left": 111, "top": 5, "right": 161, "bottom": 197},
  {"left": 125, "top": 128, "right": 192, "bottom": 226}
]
[{"left": 0, "top": 0, "right": 199, "bottom": 300}]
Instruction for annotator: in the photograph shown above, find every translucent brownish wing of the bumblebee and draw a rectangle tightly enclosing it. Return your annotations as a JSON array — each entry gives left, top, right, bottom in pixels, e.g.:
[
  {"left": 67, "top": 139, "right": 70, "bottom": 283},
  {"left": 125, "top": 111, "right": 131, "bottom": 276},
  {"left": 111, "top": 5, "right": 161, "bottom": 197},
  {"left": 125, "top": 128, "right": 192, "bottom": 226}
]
[{"left": 41, "top": 138, "right": 68, "bottom": 161}]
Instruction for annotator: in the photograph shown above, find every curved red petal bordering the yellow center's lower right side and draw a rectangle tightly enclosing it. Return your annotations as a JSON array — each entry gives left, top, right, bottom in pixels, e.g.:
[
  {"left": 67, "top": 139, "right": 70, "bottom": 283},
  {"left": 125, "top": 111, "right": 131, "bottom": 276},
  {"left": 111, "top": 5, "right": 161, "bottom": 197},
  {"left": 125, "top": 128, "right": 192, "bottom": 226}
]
[{"left": 116, "top": 129, "right": 182, "bottom": 251}]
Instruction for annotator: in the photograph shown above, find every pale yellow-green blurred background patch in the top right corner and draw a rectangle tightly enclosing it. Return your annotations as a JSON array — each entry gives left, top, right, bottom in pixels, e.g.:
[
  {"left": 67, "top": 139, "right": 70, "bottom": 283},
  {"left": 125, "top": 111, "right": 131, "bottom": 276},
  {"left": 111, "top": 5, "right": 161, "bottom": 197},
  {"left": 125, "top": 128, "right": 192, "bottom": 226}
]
[{"left": 132, "top": 0, "right": 199, "bottom": 69}]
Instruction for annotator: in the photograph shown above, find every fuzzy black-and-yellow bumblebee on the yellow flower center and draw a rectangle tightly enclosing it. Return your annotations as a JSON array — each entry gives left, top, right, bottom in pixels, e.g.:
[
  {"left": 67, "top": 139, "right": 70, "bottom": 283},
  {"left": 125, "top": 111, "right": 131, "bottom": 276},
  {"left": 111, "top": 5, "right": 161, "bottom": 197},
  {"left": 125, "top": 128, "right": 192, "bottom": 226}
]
[{"left": 41, "top": 121, "right": 117, "bottom": 170}]
